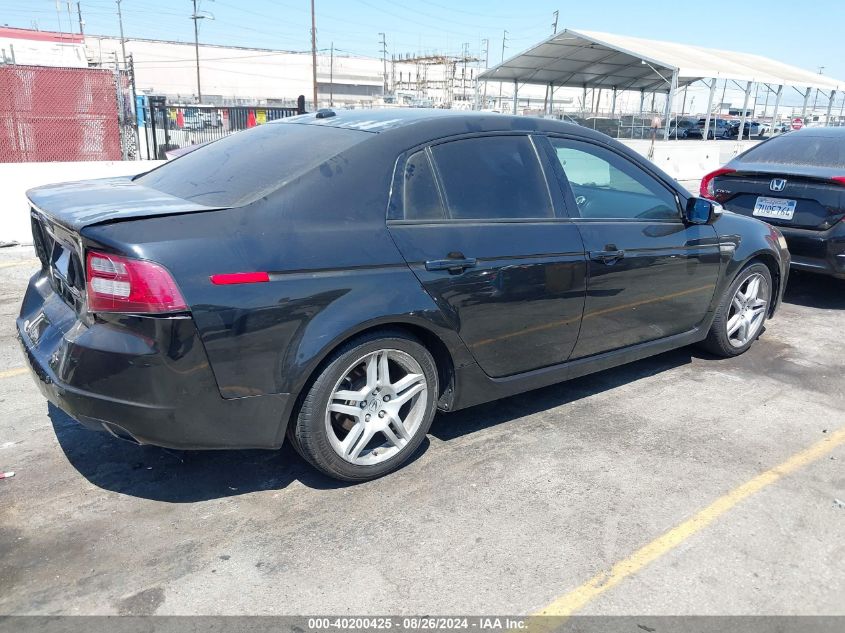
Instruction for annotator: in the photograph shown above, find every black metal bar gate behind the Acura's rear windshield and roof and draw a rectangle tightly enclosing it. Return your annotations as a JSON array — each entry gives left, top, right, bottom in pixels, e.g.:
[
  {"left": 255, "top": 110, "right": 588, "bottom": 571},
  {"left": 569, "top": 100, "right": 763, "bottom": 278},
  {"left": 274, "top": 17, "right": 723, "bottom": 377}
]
[{"left": 138, "top": 96, "right": 304, "bottom": 160}]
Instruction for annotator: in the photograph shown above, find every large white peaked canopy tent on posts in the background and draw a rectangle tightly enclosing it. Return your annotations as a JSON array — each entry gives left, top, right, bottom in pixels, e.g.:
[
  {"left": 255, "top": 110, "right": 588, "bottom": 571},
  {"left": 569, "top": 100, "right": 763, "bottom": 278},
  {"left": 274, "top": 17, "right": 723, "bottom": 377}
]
[{"left": 478, "top": 29, "right": 845, "bottom": 139}]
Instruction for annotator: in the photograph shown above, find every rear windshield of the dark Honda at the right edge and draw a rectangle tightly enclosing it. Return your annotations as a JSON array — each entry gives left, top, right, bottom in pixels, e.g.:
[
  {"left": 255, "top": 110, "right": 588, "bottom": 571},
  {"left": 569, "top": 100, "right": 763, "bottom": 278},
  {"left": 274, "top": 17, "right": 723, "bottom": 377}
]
[{"left": 742, "top": 132, "right": 845, "bottom": 167}]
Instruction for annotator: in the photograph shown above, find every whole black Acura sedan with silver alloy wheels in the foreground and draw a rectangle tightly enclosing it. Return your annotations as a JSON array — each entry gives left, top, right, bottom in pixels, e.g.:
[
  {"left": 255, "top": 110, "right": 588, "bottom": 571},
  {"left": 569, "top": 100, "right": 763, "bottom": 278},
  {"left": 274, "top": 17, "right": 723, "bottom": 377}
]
[{"left": 17, "top": 110, "right": 789, "bottom": 481}]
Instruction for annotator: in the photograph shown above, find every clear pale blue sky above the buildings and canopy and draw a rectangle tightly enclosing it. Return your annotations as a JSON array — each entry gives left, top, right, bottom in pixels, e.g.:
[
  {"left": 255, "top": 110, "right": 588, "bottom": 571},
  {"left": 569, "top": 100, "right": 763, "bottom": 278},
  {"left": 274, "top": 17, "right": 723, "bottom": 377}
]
[{"left": 0, "top": 0, "right": 845, "bottom": 111}]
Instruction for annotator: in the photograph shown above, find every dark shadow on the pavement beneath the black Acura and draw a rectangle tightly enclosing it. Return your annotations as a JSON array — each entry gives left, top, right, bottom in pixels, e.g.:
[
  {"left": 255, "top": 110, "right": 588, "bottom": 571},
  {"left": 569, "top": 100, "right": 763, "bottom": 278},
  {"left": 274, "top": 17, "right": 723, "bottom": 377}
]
[{"left": 48, "top": 348, "right": 693, "bottom": 503}]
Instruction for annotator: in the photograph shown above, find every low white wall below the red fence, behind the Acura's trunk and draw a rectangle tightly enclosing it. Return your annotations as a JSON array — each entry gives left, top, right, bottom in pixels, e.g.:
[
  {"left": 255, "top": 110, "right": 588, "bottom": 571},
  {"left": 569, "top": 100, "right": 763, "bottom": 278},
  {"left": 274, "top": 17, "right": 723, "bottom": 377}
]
[{"left": 0, "top": 160, "right": 164, "bottom": 244}]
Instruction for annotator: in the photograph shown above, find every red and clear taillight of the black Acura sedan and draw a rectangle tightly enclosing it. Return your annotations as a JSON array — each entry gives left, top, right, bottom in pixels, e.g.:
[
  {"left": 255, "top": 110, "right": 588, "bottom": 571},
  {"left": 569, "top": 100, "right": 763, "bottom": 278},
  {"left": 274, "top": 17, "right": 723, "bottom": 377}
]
[{"left": 85, "top": 251, "right": 188, "bottom": 314}]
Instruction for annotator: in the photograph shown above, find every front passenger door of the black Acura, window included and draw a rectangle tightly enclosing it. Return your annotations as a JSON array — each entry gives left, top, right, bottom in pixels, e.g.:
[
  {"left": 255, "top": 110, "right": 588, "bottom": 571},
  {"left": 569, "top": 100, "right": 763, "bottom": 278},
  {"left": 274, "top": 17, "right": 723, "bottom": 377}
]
[{"left": 548, "top": 137, "right": 720, "bottom": 358}]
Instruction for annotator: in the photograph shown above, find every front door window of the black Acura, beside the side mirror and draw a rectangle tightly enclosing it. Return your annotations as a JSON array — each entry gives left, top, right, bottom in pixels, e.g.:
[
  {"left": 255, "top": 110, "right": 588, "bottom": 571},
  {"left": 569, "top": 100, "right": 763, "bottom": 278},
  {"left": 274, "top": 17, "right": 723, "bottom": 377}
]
[{"left": 549, "top": 138, "right": 680, "bottom": 220}]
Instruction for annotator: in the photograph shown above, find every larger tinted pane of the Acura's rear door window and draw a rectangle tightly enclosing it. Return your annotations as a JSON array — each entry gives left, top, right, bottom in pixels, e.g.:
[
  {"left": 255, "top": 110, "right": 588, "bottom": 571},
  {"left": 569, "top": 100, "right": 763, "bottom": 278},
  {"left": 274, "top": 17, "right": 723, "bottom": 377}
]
[{"left": 432, "top": 136, "right": 554, "bottom": 220}]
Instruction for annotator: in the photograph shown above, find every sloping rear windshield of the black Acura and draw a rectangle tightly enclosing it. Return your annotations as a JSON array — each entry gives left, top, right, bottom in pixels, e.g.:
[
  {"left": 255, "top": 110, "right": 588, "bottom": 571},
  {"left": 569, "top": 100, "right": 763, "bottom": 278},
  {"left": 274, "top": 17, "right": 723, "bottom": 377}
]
[{"left": 136, "top": 123, "right": 371, "bottom": 207}]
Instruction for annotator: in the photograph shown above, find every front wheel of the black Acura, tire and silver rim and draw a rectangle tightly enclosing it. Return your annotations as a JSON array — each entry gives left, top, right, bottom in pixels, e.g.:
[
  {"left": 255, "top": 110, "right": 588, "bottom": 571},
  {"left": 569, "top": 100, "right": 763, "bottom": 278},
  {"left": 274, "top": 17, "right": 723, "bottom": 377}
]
[{"left": 702, "top": 263, "right": 772, "bottom": 358}]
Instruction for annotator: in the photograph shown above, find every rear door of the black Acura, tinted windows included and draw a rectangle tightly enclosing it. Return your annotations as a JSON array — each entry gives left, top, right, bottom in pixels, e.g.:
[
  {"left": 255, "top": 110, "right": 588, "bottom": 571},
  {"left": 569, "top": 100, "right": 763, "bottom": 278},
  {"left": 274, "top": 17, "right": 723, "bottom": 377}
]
[{"left": 388, "top": 134, "right": 586, "bottom": 377}]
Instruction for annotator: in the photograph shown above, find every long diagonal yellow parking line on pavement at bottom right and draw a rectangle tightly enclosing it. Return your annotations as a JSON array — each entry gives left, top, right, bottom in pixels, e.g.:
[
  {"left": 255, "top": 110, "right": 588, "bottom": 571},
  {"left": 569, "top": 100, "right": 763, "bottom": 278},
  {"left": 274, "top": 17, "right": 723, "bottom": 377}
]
[{"left": 535, "top": 427, "right": 845, "bottom": 616}]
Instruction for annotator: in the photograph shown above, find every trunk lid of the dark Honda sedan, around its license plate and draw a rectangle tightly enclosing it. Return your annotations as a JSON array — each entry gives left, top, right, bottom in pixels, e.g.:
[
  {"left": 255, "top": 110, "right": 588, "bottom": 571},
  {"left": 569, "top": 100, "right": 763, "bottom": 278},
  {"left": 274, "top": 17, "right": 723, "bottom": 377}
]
[{"left": 713, "top": 163, "right": 845, "bottom": 231}]
